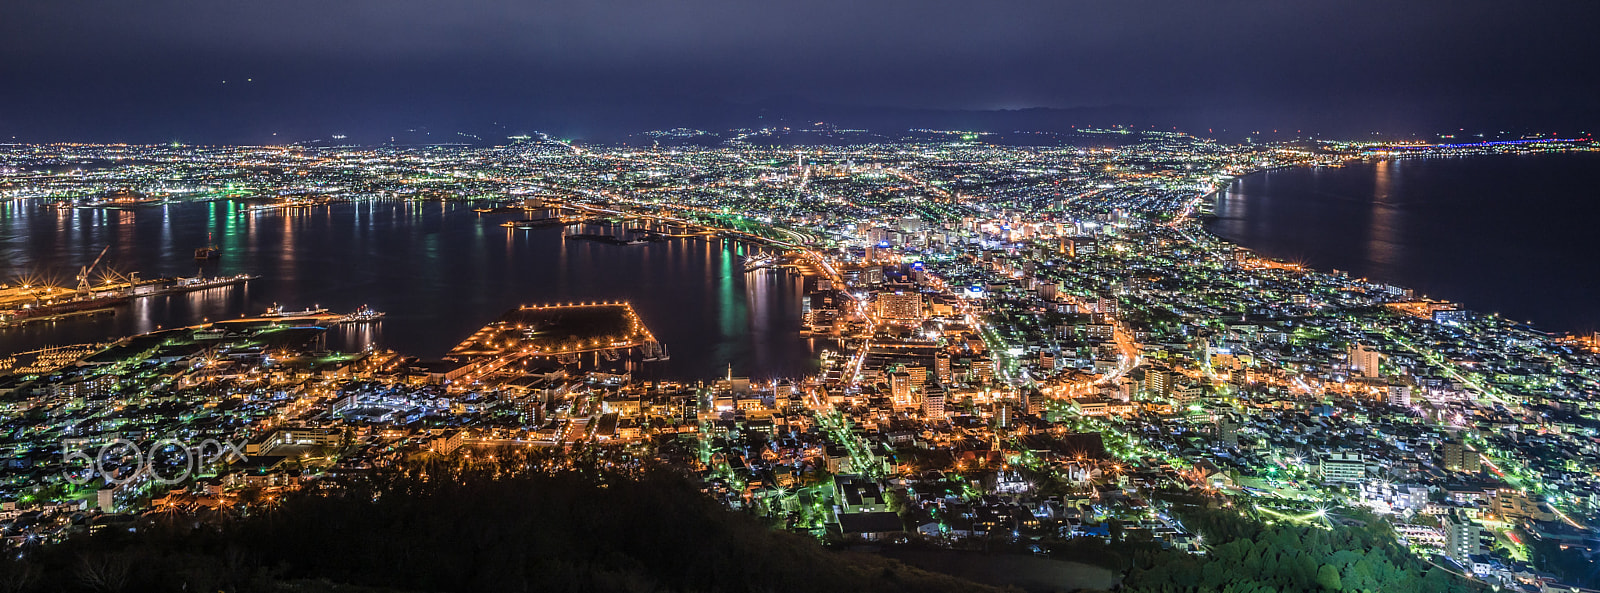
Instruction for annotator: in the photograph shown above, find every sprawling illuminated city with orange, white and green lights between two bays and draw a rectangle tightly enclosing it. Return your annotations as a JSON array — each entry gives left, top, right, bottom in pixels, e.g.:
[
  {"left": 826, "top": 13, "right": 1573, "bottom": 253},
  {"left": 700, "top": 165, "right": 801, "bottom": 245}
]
[{"left": 0, "top": 131, "right": 1600, "bottom": 590}]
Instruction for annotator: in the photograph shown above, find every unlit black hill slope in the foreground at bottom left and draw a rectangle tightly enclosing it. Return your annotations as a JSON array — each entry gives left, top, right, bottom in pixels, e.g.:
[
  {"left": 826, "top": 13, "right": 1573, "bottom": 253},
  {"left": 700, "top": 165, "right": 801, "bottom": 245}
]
[{"left": 0, "top": 465, "right": 1011, "bottom": 593}]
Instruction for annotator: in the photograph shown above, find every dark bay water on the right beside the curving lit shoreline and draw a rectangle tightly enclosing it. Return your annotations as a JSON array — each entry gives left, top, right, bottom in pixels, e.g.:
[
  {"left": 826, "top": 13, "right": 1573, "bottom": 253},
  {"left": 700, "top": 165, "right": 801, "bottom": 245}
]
[{"left": 1206, "top": 153, "right": 1600, "bottom": 331}]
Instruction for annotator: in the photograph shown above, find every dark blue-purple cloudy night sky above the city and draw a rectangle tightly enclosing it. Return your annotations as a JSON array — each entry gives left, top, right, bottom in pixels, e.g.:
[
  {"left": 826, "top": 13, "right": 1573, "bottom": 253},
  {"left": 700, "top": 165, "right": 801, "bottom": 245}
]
[{"left": 0, "top": 0, "right": 1600, "bottom": 142}]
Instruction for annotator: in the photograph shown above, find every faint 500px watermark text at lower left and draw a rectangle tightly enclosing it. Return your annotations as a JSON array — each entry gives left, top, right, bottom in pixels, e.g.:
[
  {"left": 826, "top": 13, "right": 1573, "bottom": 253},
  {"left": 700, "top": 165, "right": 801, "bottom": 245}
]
[{"left": 61, "top": 438, "right": 245, "bottom": 486}]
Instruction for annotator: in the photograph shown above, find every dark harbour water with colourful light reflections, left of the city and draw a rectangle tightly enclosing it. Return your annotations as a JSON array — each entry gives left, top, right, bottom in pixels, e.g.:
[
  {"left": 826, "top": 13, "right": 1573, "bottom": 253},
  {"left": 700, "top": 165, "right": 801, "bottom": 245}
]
[{"left": 0, "top": 200, "right": 814, "bottom": 379}]
